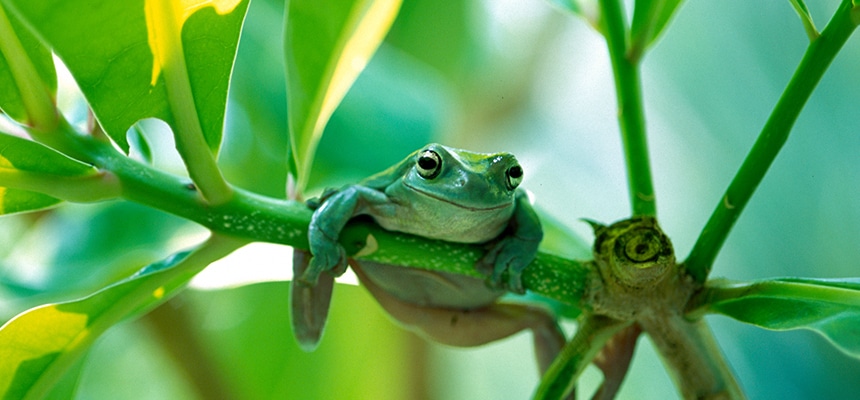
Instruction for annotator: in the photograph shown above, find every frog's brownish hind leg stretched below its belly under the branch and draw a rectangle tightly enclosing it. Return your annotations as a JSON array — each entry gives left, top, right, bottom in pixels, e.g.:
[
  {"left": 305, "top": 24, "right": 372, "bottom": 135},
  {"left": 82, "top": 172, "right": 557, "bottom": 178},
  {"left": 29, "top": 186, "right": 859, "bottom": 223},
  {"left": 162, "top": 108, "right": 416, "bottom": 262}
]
[{"left": 352, "top": 264, "right": 565, "bottom": 374}]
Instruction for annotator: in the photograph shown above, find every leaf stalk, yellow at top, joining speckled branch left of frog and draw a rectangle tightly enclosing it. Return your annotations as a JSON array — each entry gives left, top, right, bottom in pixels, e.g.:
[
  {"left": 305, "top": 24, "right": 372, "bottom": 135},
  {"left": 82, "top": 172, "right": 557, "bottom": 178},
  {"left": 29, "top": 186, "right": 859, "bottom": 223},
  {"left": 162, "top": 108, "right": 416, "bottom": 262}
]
[{"left": 147, "top": 0, "right": 232, "bottom": 205}]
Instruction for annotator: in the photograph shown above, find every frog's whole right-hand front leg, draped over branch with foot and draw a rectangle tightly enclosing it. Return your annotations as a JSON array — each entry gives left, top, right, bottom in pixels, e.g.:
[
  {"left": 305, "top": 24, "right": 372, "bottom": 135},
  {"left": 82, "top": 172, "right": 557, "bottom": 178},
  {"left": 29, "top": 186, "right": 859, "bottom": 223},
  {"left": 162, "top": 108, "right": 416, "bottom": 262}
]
[{"left": 477, "top": 191, "right": 543, "bottom": 294}]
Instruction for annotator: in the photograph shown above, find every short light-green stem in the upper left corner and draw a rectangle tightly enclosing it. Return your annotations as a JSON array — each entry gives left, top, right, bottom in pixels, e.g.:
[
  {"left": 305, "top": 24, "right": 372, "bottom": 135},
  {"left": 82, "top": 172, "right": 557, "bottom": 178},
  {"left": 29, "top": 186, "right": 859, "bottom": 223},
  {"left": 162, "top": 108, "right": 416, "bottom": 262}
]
[{"left": 0, "top": 4, "right": 59, "bottom": 132}]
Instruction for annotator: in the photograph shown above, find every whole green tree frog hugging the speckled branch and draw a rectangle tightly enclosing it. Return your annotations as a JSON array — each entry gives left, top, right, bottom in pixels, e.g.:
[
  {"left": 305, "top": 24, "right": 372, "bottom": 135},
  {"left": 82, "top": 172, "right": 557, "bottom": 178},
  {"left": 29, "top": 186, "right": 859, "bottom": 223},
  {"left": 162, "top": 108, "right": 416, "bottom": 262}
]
[{"left": 291, "top": 144, "right": 564, "bottom": 371}]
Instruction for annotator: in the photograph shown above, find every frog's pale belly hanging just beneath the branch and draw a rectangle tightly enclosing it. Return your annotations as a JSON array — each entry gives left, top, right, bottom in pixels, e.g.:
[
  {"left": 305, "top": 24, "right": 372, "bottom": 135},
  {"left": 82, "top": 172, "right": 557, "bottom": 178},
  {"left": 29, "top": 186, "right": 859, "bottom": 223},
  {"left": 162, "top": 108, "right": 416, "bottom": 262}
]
[{"left": 353, "top": 261, "right": 504, "bottom": 309}]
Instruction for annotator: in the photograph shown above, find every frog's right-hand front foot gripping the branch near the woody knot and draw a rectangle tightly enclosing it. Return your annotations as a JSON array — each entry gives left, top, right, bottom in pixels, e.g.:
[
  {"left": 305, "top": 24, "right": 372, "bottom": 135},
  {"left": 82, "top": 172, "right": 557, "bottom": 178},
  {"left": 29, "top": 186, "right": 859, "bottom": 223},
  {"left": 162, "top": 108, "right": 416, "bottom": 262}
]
[{"left": 475, "top": 237, "right": 538, "bottom": 294}]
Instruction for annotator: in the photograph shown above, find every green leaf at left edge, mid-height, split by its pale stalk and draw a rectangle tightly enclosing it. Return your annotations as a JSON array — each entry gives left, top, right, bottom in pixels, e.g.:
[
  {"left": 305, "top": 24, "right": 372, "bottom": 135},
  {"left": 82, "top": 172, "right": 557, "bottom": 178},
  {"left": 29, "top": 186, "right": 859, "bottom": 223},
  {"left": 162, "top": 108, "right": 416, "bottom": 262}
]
[{"left": 0, "top": 133, "right": 96, "bottom": 215}]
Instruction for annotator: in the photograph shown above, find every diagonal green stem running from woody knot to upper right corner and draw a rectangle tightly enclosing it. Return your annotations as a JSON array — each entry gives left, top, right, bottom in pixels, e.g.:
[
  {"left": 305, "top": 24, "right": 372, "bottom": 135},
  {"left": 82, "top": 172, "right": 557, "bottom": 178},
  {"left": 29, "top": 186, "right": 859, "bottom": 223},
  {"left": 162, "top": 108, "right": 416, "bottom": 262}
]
[{"left": 685, "top": 0, "right": 860, "bottom": 283}]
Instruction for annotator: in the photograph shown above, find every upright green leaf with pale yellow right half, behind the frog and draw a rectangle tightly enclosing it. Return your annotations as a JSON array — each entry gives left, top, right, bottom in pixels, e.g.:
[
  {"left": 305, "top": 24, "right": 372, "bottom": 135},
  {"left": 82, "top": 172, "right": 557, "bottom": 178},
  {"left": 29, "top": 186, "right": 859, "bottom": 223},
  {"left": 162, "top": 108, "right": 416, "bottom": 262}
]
[{"left": 284, "top": 0, "right": 401, "bottom": 193}]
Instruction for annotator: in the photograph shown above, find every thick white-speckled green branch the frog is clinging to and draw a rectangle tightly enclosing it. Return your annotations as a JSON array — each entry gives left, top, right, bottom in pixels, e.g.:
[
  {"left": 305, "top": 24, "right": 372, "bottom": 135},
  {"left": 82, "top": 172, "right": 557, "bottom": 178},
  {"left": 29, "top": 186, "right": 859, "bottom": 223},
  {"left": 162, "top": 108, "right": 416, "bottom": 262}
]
[{"left": 0, "top": 124, "right": 593, "bottom": 307}]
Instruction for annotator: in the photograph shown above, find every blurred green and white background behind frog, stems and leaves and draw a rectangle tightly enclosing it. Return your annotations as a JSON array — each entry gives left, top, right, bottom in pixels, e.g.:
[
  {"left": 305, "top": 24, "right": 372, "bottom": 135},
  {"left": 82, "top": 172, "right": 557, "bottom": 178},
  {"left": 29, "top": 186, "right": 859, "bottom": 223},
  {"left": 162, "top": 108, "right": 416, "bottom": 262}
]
[{"left": 0, "top": 0, "right": 860, "bottom": 399}]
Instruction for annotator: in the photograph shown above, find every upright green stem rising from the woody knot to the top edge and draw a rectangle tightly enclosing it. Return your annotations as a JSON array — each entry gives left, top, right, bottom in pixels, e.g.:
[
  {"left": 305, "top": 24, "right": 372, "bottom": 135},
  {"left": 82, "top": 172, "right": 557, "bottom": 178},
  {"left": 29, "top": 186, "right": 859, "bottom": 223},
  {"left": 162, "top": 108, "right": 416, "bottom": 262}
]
[{"left": 600, "top": 0, "right": 657, "bottom": 217}]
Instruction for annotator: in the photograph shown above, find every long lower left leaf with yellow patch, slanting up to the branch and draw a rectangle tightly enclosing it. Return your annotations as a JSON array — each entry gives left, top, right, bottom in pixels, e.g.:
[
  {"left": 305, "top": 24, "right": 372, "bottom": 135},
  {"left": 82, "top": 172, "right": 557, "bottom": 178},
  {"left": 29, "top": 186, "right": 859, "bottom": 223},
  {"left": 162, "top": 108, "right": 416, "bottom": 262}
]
[{"left": 0, "top": 236, "right": 243, "bottom": 399}]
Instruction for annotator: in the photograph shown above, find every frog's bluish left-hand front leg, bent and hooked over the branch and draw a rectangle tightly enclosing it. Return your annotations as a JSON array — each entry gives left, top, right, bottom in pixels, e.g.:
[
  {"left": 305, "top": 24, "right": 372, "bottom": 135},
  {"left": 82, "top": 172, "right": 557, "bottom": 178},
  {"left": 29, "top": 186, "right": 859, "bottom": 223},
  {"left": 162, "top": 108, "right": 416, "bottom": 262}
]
[{"left": 298, "top": 185, "right": 388, "bottom": 286}]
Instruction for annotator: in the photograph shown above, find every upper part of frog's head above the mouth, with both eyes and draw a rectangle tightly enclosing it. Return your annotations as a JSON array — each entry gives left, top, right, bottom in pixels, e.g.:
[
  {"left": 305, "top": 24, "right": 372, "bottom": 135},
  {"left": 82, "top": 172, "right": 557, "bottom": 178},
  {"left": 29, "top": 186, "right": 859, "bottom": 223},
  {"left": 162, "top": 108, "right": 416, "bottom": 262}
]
[{"left": 403, "top": 143, "right": 523, "bottom": 210}]
